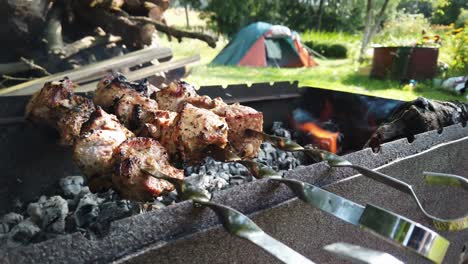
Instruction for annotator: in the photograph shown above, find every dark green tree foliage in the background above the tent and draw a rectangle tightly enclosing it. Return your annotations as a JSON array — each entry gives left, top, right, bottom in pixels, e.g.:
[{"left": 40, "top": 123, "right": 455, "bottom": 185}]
[{"left": 199, "top": 0, "right": 398, "bottom": 36}]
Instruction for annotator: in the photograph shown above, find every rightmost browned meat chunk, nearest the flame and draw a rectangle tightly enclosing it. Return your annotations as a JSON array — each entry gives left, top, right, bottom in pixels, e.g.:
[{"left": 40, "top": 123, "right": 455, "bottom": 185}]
[{"left": 212, "top": 104, "right": 263, "bottom": 158}]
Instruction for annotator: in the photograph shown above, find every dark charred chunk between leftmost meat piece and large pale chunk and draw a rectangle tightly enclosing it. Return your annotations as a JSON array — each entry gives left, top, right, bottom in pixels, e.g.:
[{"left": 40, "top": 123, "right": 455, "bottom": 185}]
[{"left": 56, "top": 95, "right": 96, "bottom": 145}]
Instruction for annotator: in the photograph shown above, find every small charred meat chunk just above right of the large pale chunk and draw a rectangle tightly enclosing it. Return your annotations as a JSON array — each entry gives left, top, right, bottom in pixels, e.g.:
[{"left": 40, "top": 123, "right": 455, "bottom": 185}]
[{"left": 114, "top": 90, "right": 158, "bottom": 130}]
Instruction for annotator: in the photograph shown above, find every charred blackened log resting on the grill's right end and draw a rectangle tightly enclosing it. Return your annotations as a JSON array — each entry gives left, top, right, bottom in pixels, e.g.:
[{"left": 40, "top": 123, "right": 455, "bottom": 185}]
[{"left": 365, "top": 97, "right": 468, "bottom": 148}]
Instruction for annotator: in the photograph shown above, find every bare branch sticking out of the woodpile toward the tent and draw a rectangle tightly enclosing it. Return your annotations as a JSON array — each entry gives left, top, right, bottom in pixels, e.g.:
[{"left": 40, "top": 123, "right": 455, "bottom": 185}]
[{"left": 127, "top": 16, "right": 217, "bottom": 48}]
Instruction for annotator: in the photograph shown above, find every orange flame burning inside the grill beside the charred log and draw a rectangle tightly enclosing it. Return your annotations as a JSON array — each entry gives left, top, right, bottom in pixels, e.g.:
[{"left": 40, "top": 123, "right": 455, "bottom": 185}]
[{"left": 299, "top": 122, "right": 339, "bottom": 153}]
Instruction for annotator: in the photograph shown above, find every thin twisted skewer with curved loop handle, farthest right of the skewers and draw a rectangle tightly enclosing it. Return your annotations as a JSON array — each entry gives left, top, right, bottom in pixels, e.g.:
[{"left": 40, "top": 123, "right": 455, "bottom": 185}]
[{"left": 246, "top": 130, "right": 468, "bottom": 231}]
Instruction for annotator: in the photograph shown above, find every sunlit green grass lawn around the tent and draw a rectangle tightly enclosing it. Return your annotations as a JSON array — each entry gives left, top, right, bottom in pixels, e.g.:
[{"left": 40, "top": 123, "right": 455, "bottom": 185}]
[{"left": 163, "top": 36, "right": 466, "bottom": 101}]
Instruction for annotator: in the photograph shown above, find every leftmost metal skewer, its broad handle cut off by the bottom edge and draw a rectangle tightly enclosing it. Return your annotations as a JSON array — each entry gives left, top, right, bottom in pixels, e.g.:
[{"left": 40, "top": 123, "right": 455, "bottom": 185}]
[{"left": 142, "top": 170, "right": 314, "bottom": 264}]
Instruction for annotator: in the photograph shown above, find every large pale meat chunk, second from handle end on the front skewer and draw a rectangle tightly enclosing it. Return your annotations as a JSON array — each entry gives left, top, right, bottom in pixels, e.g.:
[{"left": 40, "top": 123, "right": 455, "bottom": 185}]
[{"left": 73, "top": 107, "right": 134, "bottom": 189}]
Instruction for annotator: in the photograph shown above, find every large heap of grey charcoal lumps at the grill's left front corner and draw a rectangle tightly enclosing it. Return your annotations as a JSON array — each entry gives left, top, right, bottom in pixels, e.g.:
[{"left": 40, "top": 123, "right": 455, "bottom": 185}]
[{"left": 0, "top": 176, "right": 141, "bottom": 249}]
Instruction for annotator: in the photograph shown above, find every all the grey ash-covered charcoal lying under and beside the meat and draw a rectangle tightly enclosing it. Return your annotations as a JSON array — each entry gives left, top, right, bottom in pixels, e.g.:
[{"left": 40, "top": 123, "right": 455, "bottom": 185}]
[{"left": 0, "top": 122, "right": 310, "bottom": 249}]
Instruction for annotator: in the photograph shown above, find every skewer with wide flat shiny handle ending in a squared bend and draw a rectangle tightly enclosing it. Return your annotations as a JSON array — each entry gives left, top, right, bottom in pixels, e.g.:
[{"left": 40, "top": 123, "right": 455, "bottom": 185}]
[{"left": 270, "top": 178, "right": 450, "bottom": 263}]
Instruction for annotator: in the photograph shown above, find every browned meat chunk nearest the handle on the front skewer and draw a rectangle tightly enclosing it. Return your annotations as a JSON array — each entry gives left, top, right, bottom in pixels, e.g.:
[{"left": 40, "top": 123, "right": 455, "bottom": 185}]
[{"left": 112, "top": 137, "right": 184, "bottom": 201}]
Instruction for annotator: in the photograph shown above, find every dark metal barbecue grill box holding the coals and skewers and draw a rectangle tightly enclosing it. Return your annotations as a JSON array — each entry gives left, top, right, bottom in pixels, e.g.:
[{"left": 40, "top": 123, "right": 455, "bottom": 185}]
[{"left": 0, "top": 82, "right": 468, "bottom": 263}]
